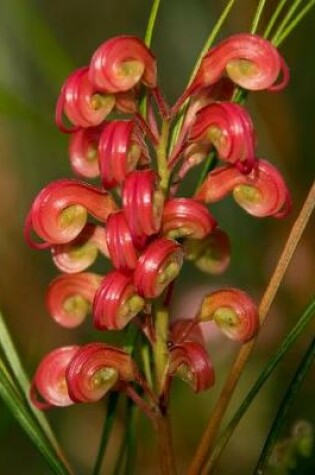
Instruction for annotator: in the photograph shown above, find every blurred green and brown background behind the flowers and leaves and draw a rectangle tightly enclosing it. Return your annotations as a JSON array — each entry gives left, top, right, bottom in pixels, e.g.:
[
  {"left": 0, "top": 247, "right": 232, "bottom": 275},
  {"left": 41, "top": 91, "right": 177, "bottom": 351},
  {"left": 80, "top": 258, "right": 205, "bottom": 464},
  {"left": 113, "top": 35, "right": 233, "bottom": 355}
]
[{"left": 0, "top": 0, "right": 315, "bottom": 475}]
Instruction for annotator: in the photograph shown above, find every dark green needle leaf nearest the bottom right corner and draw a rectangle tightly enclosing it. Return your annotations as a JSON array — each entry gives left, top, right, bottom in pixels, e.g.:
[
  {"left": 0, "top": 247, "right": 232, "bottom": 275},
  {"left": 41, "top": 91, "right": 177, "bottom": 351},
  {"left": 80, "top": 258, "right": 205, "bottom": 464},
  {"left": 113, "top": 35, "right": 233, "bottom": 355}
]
[{"left": 255, "top": 339, "right": 315, "bottom": 474}]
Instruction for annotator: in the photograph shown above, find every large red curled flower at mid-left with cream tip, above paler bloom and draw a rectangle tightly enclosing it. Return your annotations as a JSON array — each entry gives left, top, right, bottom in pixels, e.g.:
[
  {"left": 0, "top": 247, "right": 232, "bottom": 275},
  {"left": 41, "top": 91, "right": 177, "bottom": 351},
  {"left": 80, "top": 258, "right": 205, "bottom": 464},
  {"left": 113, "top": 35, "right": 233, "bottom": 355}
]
[{"left": 25, "top": 180, "right": 116, "bottom": 248}]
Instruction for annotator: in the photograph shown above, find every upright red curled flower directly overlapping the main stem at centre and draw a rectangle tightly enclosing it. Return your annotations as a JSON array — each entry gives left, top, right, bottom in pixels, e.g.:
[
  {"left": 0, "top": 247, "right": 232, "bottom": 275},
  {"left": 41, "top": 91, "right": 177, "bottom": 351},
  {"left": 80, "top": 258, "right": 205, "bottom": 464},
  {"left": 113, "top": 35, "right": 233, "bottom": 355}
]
[{"left": 122, "top": 170, "right": 164, "bottom": 247}]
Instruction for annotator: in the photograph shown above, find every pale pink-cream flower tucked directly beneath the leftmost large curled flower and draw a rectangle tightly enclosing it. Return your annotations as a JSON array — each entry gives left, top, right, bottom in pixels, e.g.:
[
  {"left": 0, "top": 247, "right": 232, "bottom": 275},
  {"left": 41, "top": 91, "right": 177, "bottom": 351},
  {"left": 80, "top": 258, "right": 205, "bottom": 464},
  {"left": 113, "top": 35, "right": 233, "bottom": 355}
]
[{"left": 51, "top": 223, "right": 109, "bottom": 274}]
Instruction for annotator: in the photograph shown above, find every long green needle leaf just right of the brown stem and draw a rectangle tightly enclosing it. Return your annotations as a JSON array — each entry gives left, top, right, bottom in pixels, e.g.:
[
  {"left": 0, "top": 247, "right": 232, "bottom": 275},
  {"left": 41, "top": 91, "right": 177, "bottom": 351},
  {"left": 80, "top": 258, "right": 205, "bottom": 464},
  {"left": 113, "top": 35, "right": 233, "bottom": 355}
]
[{"left": 207, "top": 299, "right": 315, "bottom": 473}]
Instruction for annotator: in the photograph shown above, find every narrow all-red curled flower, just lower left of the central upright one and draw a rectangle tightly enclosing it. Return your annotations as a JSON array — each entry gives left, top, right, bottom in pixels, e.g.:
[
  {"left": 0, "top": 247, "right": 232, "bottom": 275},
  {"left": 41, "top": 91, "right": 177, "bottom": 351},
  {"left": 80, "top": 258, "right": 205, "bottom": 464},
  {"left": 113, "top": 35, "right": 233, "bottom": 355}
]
[{"left": 106, "top": 211, "right": 138, "bottom": 270}]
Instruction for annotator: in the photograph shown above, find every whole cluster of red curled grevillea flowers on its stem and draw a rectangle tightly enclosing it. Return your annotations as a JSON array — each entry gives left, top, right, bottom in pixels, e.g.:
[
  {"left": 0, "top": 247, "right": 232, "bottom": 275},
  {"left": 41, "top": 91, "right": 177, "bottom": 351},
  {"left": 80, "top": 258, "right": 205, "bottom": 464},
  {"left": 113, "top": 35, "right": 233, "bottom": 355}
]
[{"left": 25, "top": 34, "right": 290, "bottom": 415}]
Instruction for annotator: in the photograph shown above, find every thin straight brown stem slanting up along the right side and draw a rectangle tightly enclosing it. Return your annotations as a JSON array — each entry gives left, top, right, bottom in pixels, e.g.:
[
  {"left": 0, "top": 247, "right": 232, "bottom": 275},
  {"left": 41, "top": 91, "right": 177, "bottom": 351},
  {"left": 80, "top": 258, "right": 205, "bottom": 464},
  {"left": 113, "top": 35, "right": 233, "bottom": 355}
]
[{"left": 188, "top": 181, "right": 315, "bottom": 475}]
